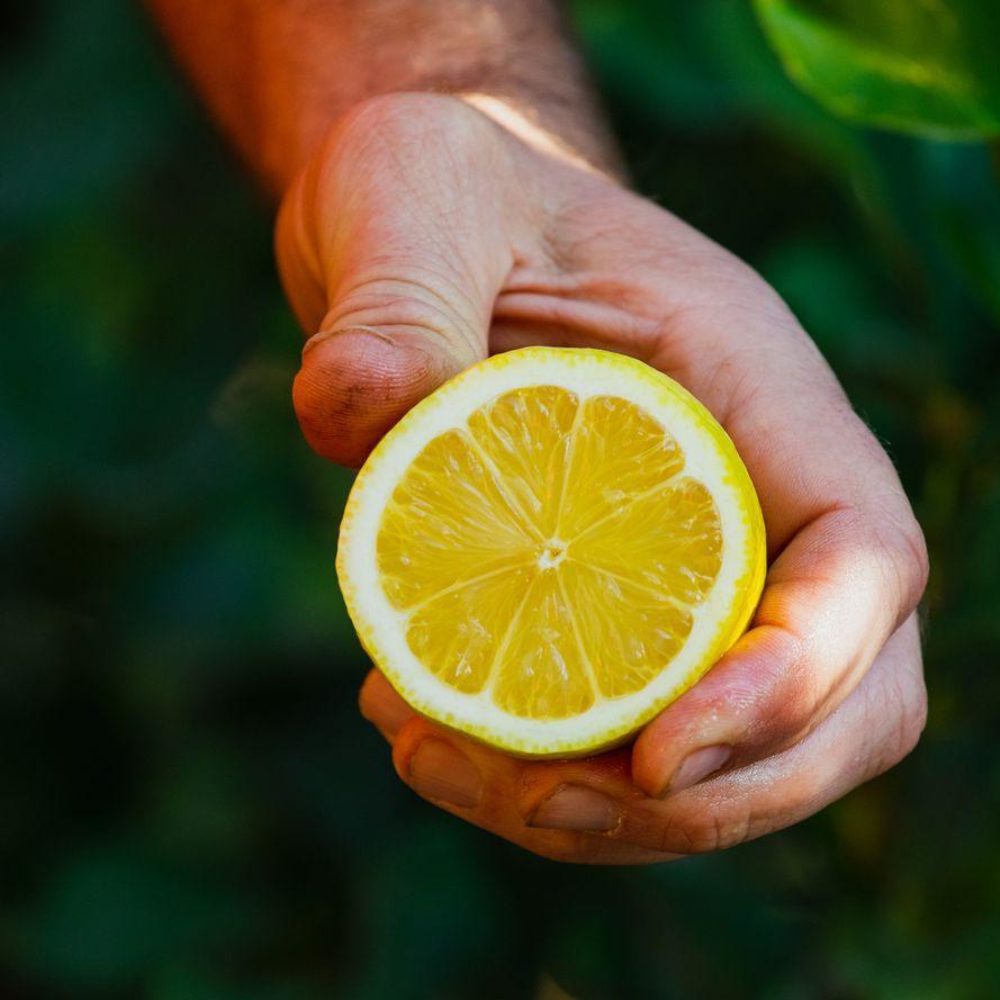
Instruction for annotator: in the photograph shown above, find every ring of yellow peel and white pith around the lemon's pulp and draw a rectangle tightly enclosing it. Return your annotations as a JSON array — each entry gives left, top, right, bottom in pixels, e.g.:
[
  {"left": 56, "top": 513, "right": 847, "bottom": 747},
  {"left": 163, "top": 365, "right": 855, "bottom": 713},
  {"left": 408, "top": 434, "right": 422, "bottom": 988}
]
[{"left": 337, "top": 347, "right": 766, "bottom": 757}]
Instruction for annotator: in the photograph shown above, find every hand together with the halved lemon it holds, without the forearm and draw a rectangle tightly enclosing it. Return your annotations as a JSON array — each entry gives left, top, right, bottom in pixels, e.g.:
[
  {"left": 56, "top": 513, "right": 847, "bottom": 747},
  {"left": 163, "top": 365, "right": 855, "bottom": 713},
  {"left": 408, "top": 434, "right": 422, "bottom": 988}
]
[{"left": 277, "top": 95, "right": 926, "bottom": 863}]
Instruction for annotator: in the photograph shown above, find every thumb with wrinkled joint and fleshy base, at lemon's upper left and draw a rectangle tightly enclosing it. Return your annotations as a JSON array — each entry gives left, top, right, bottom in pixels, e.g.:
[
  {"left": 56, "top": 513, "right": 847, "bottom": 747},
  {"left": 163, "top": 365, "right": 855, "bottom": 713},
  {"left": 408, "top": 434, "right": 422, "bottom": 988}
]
[{"left": 277, "top": 95, "right": 513, "bottom": 466}]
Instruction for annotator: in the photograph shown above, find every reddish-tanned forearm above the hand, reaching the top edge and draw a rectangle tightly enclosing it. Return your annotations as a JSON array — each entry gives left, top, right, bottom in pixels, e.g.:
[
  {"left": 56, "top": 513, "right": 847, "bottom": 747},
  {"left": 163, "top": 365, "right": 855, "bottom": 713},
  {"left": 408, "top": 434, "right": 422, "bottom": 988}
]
[{"left": 147, "top": 0, "right": 615, "bottom": 193}]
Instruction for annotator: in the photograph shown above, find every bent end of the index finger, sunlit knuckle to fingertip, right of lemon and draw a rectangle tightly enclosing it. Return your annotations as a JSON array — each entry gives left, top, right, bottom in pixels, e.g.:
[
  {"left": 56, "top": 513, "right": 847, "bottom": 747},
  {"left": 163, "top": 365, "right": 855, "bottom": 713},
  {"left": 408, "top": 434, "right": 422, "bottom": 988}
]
[{"left": 633, "top": 504, "right": 924, "bottom": 796}]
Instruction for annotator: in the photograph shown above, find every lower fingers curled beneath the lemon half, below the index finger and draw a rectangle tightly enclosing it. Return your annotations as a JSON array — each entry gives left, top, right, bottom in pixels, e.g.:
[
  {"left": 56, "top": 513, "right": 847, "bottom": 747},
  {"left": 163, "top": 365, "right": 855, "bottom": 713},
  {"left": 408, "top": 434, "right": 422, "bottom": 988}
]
[{"left": 362, "top": 618, "right": 926, "bottom": 864}]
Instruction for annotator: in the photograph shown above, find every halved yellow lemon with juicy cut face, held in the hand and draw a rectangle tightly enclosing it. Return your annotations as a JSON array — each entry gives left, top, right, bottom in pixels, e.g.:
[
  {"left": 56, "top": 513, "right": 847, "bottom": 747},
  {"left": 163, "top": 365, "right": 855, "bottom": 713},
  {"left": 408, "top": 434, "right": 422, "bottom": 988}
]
[{"left": 337, "top": 347, "right": 766, "bottom": 756}]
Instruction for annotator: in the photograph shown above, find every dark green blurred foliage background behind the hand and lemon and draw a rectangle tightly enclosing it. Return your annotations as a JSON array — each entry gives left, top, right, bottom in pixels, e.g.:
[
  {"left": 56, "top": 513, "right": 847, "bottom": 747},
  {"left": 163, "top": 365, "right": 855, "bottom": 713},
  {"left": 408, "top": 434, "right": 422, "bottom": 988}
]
[{"left": 0, "top": 0, "right": 1000, "bottom": 1000}]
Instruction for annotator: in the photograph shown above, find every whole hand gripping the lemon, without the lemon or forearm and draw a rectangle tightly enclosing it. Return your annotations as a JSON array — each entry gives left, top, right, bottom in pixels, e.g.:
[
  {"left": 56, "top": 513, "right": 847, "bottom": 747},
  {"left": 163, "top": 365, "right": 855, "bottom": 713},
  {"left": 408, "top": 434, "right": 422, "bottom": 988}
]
[{"left": 277, "top": 94, "right": 927, "bottom": 863}]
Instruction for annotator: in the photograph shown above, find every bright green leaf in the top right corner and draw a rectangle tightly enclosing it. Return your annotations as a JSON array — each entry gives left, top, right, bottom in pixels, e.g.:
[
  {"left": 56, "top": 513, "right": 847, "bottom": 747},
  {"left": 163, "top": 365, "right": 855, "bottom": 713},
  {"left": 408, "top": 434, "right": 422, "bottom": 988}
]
[{"left": 754, "top": 0, "right": 1000, "bottom": 139}]
